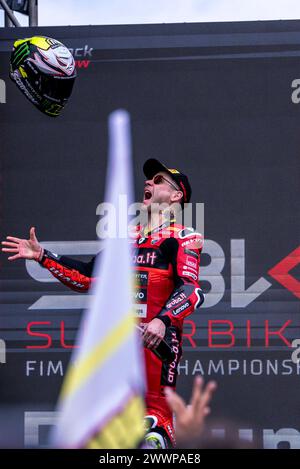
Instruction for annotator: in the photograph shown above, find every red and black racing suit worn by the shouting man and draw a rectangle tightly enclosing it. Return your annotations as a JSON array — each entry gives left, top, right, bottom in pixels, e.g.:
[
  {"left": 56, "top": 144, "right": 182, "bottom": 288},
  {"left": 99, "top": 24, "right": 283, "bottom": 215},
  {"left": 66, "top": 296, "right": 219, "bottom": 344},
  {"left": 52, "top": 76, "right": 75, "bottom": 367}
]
[{"left": 40, "top": 221, "right": 204, "bottom": 446}]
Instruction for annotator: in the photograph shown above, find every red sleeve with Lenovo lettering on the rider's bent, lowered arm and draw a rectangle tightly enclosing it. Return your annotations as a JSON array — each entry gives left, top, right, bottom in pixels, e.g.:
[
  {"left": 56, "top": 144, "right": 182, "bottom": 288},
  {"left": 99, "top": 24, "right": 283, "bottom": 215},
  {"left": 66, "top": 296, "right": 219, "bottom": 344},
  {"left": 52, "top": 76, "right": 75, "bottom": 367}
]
[{"left": 156, "top": 233, "right": 204, "bottom": 327}]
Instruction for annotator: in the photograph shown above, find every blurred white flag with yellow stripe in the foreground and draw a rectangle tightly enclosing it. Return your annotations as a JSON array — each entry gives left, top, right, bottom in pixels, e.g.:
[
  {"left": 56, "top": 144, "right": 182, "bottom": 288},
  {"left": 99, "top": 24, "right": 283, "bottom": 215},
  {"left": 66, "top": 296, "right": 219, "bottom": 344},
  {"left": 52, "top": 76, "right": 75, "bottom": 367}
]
[{"left": 52, "top": 110, "right": 145, "bottom": 448}]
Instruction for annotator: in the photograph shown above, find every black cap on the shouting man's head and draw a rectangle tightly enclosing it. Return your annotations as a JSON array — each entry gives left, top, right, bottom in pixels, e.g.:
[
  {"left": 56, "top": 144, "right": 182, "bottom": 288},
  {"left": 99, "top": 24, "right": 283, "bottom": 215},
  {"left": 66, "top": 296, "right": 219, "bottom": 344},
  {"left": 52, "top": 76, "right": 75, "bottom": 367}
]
[{"left": 143, "top": 158, "right": 192, "bottom": 202}]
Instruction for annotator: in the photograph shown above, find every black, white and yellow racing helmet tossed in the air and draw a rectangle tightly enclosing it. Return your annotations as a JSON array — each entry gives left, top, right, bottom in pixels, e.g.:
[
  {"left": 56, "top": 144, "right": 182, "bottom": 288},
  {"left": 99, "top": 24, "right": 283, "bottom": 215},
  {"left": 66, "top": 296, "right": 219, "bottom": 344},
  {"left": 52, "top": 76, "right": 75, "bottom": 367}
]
[{"left": 10, "top": 36, "right": 77, "bottom": 117}]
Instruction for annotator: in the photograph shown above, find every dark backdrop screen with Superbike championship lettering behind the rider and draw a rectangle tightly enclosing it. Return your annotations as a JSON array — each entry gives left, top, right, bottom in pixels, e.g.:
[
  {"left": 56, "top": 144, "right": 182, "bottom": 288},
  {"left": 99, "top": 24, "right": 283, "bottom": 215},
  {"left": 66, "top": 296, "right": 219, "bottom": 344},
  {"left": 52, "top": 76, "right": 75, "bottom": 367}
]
[{"left": 0, "top": 21, "right": 300, "bottom": 448}]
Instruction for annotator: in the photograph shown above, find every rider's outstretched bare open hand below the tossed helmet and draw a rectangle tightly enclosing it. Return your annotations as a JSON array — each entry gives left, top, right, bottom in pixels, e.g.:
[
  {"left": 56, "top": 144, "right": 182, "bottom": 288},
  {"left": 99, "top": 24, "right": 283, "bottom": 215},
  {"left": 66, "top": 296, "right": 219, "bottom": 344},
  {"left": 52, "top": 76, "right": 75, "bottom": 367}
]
[{"left": 2, "top": 227, "right": 44, "bottom": 261}]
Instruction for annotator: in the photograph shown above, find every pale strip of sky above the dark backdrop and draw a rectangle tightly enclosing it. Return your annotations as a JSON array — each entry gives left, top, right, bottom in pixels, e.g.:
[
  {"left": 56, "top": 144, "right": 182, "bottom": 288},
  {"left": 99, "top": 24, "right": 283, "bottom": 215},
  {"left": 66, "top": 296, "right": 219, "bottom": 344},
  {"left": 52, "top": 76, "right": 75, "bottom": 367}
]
[{"left": 0, "top": 0, "right": 300, "bottom": 26}]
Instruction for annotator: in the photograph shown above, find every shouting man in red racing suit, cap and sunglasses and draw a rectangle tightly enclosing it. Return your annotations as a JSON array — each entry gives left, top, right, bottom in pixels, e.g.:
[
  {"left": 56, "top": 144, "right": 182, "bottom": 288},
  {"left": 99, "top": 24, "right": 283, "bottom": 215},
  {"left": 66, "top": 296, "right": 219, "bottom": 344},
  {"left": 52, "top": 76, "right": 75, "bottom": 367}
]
[{"left": 2, "top": 159, "right": 204, "bottom": 448}]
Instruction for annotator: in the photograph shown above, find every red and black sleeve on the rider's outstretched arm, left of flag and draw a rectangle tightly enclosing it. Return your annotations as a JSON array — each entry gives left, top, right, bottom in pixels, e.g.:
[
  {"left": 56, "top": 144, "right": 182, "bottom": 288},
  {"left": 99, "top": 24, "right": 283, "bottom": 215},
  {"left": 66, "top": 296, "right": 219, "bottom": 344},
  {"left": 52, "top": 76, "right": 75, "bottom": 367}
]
[{"left": 40, "top": 249, "right": 97, "bottom": 292}]
